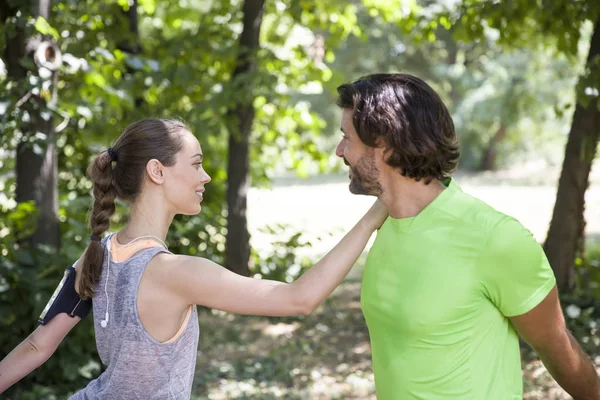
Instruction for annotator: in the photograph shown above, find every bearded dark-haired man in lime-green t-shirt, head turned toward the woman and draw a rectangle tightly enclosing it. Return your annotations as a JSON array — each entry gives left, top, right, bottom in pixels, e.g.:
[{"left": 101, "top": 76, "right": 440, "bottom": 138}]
[{"left": 336, "top": 74, "right": 600, "bottom": 400}]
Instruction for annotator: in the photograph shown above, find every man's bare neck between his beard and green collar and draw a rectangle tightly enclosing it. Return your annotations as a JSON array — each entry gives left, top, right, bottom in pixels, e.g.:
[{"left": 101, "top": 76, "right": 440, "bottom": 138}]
[{"left": 379, "top": 175, "right": 446, "bottom": 218}]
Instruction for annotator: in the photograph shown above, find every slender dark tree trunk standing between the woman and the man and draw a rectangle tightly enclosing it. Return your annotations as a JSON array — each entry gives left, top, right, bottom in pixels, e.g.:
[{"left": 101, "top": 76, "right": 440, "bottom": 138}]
[{"left": 225, "top": 0, "right": 265, "bottom": 276}]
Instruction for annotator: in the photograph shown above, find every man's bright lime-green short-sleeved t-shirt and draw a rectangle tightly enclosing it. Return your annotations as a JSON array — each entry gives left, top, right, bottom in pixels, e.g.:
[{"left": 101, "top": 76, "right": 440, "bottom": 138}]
[{"left": 361, "top": 180, "right": 555, "bottom": 400}]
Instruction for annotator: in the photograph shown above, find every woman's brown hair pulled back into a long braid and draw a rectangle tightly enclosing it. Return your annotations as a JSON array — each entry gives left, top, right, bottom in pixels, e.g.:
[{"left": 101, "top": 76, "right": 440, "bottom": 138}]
[{"left": 79, "top": 119, "right": 189, "bottom": 298}]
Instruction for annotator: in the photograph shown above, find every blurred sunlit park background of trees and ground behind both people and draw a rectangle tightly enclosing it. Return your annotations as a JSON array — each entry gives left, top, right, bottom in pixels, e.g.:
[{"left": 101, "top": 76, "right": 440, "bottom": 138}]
[{"left": 0, "top": 0, "right": 600, "bottom": 399}]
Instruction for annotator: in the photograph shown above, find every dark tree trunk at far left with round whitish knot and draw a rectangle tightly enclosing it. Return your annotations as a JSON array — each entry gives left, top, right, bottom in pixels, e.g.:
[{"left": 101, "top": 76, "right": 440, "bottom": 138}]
[{"left": 0, "top": 0, "right": 64, "bottom": 252}]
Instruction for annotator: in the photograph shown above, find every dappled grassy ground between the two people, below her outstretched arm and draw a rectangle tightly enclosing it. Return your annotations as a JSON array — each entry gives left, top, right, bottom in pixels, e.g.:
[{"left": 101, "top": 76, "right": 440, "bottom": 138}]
[{"left": 193, "top": 281, "right": 375, "bottom": 399}]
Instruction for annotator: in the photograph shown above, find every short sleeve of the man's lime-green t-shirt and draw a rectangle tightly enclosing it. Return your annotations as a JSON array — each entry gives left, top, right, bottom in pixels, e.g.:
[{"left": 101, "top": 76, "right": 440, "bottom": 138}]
[{"left": 479, "top": 217, "right": 556, "bottom": 317}]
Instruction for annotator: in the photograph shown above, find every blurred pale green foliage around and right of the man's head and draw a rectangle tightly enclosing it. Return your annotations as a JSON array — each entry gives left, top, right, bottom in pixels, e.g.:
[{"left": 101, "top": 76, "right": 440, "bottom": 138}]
[{"left": 302, "top": 2, "right": 590, "bottom": 169}]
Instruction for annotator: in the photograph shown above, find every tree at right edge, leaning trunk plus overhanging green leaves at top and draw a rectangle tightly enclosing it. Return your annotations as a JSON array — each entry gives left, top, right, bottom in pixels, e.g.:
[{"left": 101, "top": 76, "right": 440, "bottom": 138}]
[{"left": 422, "top": 0, "right": 600, "bottom": 291}]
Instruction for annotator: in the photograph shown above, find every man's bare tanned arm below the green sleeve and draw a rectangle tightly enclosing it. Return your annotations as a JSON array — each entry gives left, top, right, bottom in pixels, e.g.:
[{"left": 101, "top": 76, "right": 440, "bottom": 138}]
[{"left": 510, "top": 286, "right": 600, "bottom": 400}]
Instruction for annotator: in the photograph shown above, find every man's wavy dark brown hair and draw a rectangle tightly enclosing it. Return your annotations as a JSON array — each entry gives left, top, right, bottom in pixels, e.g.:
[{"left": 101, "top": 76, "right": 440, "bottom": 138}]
[{"left": 337, "top": 74, "right": 459, "bottom": 183}]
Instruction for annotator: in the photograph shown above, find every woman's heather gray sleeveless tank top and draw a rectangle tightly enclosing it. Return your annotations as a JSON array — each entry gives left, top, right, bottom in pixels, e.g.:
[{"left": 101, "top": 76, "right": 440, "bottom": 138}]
[{"left": 70, "top": 236, "right": 199, "bottom": 400}]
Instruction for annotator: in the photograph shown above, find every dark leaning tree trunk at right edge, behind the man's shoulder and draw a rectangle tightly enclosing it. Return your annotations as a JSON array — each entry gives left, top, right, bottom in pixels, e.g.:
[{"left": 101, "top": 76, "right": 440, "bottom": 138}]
[{"left": 544, "top": 20, "right": 600, "bottom": 291}]
